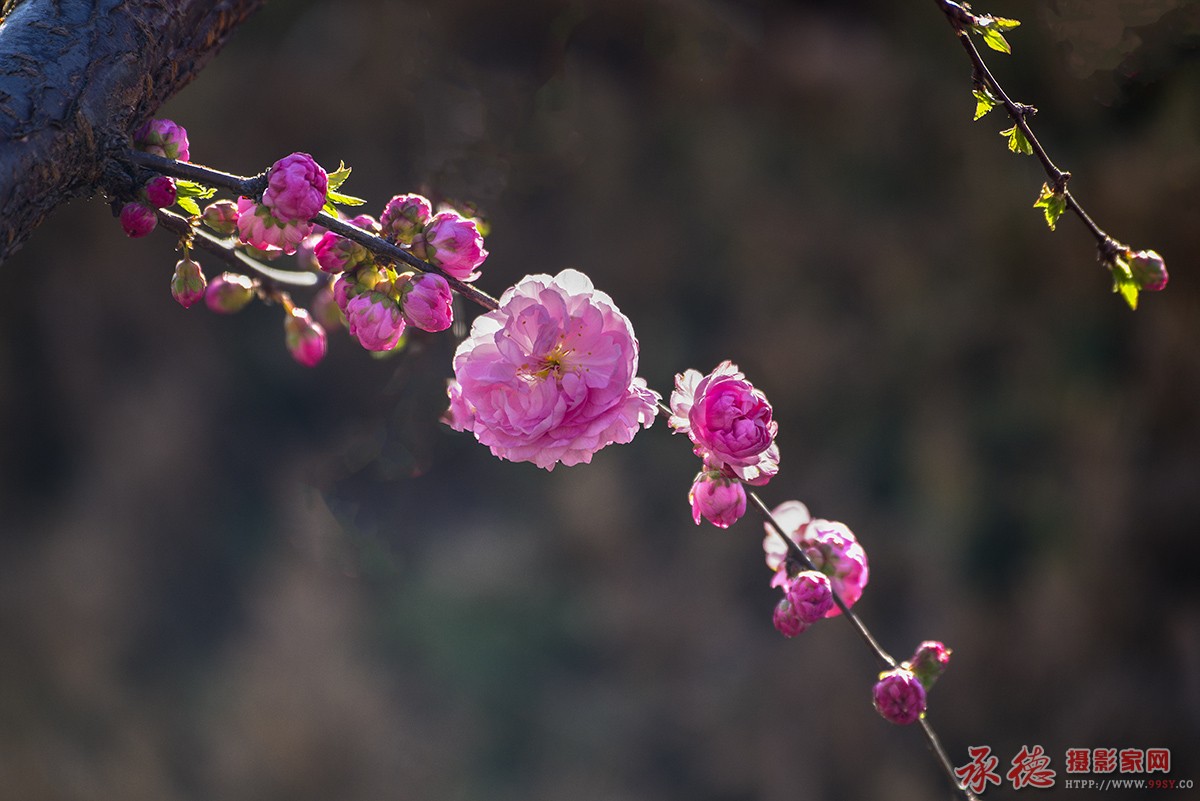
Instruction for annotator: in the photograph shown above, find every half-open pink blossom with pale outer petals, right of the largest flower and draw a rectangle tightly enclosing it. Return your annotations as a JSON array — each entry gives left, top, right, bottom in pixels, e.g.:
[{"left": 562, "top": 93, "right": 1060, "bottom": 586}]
[{"left": 670, "top": 361, "right": 779, "bottom": 484}]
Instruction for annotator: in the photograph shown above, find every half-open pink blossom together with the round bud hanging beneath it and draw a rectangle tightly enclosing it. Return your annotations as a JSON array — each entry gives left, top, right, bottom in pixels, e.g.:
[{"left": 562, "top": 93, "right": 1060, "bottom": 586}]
[{"left": 670, "top": 361, "right": 779, "bottom": 529}]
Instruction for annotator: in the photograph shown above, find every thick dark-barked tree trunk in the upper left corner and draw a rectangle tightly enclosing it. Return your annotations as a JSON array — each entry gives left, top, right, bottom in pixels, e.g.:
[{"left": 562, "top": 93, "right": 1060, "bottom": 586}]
[{"left": 0, "top": 0, "right": 265, "bottom": 261}]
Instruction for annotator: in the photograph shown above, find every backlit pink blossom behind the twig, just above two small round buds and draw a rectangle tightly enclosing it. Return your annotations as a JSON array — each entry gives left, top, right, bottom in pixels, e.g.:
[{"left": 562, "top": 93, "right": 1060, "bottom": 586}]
[{"left": 762, "top": 500, "right": 870, "bottom": 618}]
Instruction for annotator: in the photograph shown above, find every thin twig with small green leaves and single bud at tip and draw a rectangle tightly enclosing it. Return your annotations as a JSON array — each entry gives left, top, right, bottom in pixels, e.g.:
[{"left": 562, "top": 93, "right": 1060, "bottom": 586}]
[{"left": 935, "top": 0, "right": 1168, "bottom": 308}]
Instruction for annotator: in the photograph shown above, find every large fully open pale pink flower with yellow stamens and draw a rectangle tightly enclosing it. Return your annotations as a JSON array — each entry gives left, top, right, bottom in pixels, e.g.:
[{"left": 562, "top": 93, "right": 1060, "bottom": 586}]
[{"left": 446, "top": 270, "right": 659, "bottom": 470}]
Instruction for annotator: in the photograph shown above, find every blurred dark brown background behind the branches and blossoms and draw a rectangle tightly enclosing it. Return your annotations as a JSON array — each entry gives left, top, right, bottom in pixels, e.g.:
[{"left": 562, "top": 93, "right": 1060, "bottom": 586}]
[{"left": 0, "top": 0, "right": 1200, "bottom": 801}]
